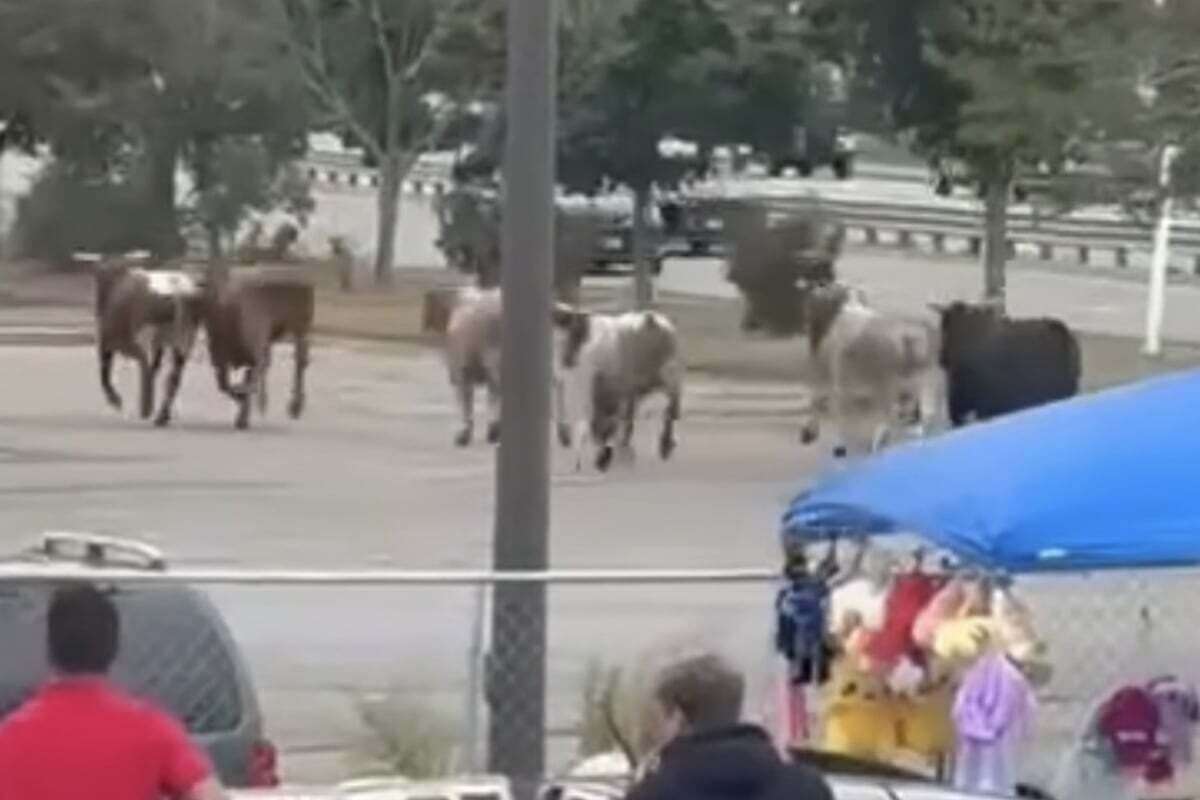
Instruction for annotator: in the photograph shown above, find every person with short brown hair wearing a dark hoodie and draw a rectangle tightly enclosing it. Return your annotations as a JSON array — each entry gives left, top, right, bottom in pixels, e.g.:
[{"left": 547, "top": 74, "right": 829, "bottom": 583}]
[{"left": 626, "top": 655, "right": 833, "bottom": 800}]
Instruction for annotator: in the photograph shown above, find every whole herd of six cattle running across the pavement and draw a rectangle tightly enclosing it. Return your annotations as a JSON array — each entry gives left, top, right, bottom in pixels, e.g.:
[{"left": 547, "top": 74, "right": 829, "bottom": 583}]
[{"left": 77, "top": 215, "right": 1080, "bottom": 470}]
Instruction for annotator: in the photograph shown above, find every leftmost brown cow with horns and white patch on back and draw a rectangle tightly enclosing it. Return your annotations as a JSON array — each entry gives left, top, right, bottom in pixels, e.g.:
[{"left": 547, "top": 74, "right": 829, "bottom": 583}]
[{"left": 81, "top": 252, "right": 204, "bottom": 427}]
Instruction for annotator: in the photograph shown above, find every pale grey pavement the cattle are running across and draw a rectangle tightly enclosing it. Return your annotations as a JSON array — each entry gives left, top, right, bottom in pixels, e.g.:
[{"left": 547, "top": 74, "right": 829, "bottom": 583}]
[{"left": 0, "top": 343, "right": 811, "bottom": 777}]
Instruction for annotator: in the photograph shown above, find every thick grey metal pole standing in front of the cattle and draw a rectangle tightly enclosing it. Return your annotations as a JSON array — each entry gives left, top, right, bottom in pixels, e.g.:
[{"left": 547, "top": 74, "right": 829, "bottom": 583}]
[{"left": 487, "top": 0, "right": 557, "bottom": 800}]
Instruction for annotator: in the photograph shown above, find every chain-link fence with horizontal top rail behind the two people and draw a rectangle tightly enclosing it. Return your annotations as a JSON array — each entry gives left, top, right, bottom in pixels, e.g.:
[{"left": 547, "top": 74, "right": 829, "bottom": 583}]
[{"left": 2, "top": 571, "right": 1200, "bottom": 786}]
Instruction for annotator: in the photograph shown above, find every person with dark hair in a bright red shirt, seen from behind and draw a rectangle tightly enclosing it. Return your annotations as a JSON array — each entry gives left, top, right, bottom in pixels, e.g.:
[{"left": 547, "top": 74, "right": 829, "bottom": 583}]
[{"left": 0, "top": 584, "right": 226, "bottom": 800}]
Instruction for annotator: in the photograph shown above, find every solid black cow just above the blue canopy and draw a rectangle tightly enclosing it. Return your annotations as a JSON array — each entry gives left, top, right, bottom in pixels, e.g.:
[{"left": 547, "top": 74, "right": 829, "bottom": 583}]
[{"left": 934, "top": 302, "right": 1081, "bottom": 427}]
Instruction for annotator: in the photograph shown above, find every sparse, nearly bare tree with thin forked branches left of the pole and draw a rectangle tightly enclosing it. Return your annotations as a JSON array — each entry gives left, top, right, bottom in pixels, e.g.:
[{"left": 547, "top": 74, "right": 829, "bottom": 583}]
[{"left": 281, "top": 0, "right": 476, "bottom": 282}]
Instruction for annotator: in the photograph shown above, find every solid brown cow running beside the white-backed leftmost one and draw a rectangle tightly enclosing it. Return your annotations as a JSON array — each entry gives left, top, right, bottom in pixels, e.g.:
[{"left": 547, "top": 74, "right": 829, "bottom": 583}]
[{"left": 204, "top": 265, "right": 316, "bottom": 429}]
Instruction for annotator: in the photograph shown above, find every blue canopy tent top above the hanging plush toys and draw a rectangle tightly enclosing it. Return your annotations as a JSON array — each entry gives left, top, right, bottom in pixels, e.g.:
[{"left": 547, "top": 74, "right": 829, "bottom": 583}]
[{"left": 784, "top": 371, "right": 1200, "bottom": 575}]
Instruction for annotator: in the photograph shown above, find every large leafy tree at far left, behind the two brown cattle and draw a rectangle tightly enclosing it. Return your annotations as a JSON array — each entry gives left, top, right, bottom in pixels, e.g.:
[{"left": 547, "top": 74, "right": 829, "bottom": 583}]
[{"left": 0, "top": 0, "right": 306, "bottom": 255}]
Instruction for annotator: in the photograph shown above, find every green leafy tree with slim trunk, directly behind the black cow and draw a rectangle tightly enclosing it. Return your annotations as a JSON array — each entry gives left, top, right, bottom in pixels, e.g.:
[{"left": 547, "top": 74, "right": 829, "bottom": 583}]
[{"left": 806, "top": 0, "right": 1124, "bottom": 306}]
